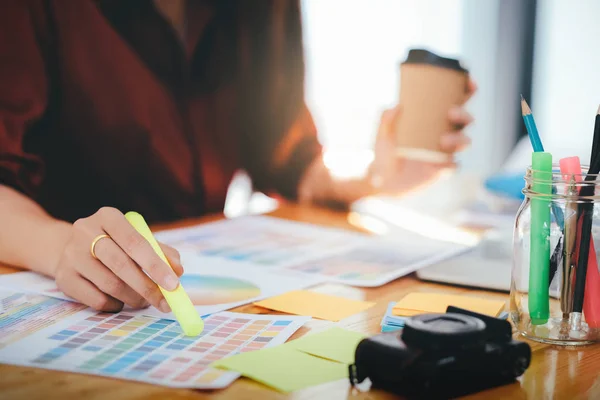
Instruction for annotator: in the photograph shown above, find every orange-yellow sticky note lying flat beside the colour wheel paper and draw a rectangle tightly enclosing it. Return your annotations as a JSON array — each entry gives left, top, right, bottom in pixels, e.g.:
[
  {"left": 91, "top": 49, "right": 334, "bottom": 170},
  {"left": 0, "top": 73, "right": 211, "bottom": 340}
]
[{"left": 254, "top": 290, "right": 375, "bottom": 321}]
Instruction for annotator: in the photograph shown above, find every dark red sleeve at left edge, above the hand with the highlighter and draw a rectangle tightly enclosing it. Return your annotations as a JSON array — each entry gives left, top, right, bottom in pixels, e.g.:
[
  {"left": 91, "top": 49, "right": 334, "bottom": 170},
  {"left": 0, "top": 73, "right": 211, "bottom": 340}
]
[{"left": 0, "top": 0, "right": 48, "bottom": 196}]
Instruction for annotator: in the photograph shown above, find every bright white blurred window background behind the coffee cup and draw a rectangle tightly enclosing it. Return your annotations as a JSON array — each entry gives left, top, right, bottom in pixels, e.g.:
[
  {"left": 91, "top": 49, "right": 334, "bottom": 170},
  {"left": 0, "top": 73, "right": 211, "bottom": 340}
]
[{"left": 226, "top": 0, "right": 600, "bottom": 225}]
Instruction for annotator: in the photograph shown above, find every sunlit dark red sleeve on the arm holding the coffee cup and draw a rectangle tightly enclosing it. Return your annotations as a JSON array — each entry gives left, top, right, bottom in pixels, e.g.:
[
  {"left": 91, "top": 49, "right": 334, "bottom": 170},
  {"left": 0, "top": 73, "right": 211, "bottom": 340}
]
[{"left": 240, "top": 0, "right": 321, "bottom": 199}]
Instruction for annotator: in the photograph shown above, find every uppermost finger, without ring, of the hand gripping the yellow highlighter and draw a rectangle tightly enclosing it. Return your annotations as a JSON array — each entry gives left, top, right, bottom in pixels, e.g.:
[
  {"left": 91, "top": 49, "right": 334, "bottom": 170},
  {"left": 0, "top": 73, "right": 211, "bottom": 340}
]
[{"left": 97, "top": 207, "right": 179, "bottom": 290}]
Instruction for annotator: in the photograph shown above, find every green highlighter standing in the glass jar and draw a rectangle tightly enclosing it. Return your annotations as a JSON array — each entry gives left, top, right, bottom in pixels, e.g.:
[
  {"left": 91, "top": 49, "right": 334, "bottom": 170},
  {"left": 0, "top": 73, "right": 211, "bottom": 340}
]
[{"left": 529, "top": 152, "right": 552, "bottom": 325}]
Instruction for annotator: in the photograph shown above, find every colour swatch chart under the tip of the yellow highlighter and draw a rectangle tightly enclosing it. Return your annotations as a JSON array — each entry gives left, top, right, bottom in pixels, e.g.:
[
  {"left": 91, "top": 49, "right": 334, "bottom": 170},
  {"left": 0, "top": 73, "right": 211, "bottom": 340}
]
[{"left": 0, "top": 293, "right": 310, "bottom": 389}]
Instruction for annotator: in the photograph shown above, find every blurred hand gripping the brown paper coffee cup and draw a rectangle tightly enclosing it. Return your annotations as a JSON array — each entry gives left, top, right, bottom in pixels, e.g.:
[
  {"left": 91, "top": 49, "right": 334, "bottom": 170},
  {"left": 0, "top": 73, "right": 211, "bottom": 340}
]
[{"left": 369, "top": 81, "right": 476, "bottom": 194}]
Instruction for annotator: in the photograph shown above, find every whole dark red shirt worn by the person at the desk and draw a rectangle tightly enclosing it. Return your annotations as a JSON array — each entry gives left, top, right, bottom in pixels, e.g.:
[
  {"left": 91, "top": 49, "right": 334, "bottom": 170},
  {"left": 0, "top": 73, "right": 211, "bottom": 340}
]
[{"left": 0, "top": 0, "right": 321, "bottom": 221}]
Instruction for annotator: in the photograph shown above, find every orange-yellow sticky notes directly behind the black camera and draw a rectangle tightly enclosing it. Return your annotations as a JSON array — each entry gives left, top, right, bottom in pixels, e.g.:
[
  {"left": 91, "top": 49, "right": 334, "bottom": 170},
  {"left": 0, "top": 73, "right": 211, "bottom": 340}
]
[{"left": 393, "top": 293, "right": 505, "bottom": 317}]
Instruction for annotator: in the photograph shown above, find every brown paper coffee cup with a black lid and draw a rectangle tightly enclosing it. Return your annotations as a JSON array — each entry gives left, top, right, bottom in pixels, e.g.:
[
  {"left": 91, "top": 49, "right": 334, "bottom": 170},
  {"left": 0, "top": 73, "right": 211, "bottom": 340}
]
[{"left": 395, "top": 49, "right": 469, "bottom": 163}]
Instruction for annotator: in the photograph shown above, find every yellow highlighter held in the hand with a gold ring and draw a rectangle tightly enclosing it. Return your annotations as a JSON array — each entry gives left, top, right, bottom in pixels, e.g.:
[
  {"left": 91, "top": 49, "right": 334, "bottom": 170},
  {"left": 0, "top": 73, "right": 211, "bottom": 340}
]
[{"left": 125, "top": 212, "right": 204, "bottom": 336}]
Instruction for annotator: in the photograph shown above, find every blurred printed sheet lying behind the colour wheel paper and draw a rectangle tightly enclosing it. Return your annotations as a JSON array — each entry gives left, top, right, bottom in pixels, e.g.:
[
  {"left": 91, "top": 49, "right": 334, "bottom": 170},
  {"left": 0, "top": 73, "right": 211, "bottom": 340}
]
[{"left": 156, "top": 216, "right": 473, "bottom": 287}]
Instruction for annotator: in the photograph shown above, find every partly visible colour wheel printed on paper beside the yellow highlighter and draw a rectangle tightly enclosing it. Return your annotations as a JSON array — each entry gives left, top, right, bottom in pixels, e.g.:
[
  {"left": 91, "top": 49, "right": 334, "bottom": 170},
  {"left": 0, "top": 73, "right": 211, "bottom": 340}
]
[{"left": 181, "top": 274, "right": 260, "bottom": 306}]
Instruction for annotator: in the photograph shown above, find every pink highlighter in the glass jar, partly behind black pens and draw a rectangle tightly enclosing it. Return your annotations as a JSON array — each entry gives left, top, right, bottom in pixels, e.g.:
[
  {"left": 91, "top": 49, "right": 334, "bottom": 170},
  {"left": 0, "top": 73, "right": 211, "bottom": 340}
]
[{"left": 560, "top": 157, "right": 600, "bottom": 328}]
